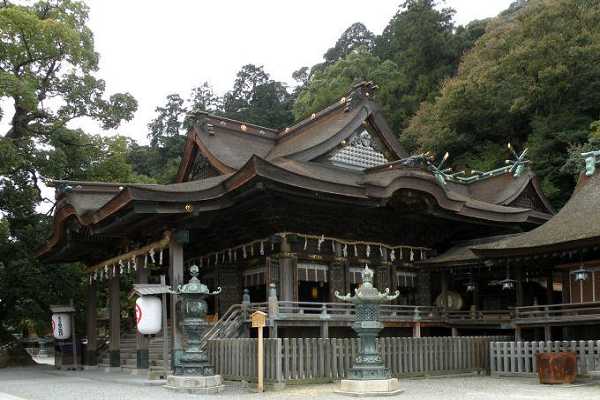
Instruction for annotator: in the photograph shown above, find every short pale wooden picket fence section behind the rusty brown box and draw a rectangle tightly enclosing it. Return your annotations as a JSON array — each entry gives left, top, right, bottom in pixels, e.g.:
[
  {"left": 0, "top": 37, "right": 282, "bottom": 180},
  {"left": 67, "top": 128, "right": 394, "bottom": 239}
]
[{"left": 490, "top": 340, "right": 600, "bottom": 376}]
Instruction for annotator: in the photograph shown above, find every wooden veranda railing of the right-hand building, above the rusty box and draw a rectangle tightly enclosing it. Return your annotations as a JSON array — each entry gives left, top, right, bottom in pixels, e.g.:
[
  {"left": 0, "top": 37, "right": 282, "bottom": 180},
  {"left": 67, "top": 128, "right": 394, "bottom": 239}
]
[{"left": 514, "top": 302, "right": 600, "bottom": 324}]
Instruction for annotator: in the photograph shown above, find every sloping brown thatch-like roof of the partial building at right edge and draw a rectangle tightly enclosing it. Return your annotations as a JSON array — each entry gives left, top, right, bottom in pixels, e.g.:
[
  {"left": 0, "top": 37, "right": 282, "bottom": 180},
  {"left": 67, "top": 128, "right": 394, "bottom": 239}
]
[{"left": 473, "top": 173, "right": 600, "bottom": 257}]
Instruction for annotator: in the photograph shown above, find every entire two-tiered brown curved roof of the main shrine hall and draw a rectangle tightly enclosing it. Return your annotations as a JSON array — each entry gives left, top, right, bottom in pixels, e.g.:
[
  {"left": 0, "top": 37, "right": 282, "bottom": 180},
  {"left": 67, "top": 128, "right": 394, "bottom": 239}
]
[{"left": 41, "top": 84, "right": 552, "bottom": 260}]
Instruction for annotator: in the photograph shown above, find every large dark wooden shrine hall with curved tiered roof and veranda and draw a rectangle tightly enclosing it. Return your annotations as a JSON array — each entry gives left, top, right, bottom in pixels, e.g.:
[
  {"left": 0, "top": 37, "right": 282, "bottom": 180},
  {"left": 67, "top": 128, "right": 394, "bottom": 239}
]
[{"left": 40, "top": 83, "right": 600, "bottom": 368}]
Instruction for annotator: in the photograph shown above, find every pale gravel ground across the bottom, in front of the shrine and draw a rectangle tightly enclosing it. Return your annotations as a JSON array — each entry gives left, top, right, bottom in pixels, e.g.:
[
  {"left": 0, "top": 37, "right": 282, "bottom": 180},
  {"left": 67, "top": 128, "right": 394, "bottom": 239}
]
[{"left": 0, "top": 366, "right": 600, "bottom": 400}]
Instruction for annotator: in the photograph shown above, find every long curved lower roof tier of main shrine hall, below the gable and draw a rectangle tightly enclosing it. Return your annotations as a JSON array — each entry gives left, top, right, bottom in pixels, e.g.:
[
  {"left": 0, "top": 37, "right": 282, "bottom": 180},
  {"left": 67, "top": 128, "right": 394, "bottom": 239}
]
[{"left": 42, "top": 155, "right": 550, "bottom": 260}]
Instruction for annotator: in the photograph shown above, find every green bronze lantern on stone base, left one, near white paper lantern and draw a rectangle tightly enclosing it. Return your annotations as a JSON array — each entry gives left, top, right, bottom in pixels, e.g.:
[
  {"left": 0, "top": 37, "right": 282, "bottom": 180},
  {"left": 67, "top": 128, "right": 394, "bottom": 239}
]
[{"left": 165, "top": 265, "right": 223, "bottom": 393}]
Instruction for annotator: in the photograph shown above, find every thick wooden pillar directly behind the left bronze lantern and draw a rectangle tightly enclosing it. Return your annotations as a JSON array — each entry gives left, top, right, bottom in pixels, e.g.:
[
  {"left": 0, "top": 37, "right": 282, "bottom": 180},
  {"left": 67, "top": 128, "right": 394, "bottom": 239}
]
[{"left": 169, "top": 235, "right": 183, "bottom": 368}]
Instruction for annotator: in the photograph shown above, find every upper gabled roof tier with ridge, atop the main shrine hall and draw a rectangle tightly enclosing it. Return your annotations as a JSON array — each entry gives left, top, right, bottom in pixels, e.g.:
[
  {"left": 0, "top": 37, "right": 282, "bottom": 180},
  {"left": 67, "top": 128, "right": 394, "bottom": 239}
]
[{"left": 177, "top": 82, "right": 407, "bottom": 182}]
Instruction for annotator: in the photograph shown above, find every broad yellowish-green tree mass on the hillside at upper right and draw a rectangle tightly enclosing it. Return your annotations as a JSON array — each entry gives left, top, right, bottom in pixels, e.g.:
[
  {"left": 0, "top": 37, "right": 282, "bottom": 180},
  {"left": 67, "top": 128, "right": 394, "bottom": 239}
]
[{"left": 403, "top": 0, "right": 600, "bottom": 206}]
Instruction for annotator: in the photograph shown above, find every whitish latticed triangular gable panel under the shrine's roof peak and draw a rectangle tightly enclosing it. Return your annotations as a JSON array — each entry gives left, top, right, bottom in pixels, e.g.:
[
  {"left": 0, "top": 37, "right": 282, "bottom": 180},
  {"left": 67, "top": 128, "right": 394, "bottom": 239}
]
[{"left": 326, "top": 129, "right": 389, "bottom": 170}]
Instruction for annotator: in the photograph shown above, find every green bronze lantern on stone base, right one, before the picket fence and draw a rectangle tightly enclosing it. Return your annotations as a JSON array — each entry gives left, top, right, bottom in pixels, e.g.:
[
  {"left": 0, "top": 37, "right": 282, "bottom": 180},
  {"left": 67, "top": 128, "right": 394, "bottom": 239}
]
[{"left": 335, "top": 265, "right": 402, "bottom": 396}]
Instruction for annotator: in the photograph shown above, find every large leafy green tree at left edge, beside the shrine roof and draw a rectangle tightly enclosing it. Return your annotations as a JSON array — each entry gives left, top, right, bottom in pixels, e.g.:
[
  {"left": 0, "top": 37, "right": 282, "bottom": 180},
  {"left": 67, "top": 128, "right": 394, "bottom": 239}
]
[{"left": 0, "top": 0, "right": 137, "bottom": 340}]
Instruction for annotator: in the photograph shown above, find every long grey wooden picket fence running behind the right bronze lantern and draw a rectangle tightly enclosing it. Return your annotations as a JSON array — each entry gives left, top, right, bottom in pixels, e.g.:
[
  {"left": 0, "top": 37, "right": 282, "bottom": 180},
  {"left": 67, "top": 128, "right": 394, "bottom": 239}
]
[{"left": 208, "top": 336, "right": 506, "bottom": 384}]
